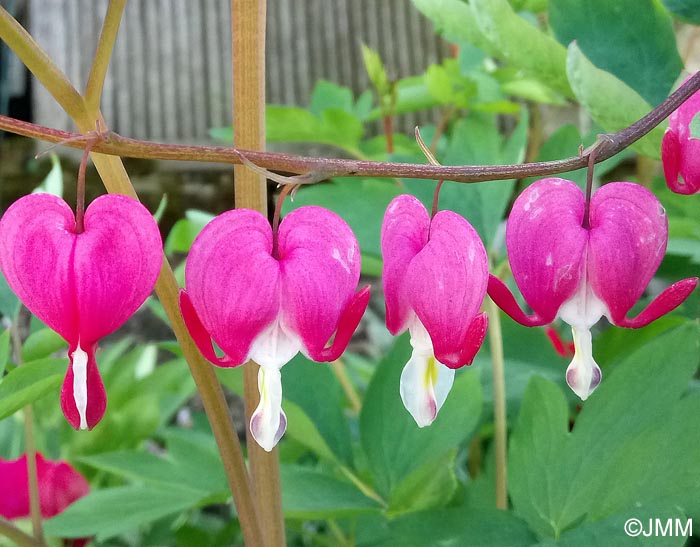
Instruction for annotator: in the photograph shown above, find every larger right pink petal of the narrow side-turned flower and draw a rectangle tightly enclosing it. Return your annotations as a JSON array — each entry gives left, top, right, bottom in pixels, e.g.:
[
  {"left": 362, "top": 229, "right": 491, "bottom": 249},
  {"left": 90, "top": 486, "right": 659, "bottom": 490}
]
[{"left": 400, "top": 211, "right": 488, "bottom": 368}]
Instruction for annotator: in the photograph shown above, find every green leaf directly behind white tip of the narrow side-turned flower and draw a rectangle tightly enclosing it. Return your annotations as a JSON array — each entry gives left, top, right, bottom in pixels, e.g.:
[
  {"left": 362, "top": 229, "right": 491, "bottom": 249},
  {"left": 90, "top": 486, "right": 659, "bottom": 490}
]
[{"left": 360, "top": 335, "right": 481, "bottom": 498}]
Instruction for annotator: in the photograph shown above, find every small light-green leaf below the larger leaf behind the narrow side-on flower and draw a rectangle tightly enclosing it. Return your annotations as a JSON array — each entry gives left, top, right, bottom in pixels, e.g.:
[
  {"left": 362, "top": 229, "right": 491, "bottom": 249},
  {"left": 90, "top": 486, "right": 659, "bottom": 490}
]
[{"left": 387, "top": 449, "right": 459, "bottom": 518}]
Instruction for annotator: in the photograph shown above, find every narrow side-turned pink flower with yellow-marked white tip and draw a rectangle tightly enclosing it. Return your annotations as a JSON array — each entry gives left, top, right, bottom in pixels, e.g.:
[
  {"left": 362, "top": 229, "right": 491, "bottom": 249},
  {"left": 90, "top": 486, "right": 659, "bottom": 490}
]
[{"left": 382, "top": 195, "right": 488, "bottom": 427}]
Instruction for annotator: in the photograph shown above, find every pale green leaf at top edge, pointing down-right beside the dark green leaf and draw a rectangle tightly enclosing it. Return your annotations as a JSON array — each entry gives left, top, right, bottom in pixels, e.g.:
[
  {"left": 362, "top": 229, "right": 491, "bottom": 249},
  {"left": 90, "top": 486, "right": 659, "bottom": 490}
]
[{"left": 471, "top": 0, "right": 573, "bottom": 97}]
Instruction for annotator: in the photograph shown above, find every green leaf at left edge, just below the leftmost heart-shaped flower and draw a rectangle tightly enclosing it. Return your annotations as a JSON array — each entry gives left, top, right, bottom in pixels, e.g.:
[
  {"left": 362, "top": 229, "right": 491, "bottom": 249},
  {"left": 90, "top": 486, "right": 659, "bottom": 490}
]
[{"left": 0, "top": 359, "right": 67, "bottom": 420}]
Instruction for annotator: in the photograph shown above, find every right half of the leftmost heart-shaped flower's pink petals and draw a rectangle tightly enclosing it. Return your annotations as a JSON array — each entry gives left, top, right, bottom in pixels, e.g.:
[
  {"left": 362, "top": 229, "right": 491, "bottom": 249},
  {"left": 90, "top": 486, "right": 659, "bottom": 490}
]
[{"left": 73, "top": 194, "right": 163, "bottom": 344}]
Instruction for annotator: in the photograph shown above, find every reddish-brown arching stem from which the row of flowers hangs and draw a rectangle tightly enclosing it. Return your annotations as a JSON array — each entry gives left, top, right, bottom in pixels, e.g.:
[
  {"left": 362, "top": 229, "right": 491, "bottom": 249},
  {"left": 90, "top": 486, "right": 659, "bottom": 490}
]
[{"left": 0, "top": 69, "right": 700, "bottom": 184}]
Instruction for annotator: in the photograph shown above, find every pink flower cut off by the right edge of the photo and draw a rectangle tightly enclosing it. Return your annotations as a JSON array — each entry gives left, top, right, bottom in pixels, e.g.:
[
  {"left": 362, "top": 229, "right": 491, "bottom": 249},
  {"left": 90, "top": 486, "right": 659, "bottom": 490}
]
[{"left": 661, "top": 80, "right": 700, "bottom": 194}]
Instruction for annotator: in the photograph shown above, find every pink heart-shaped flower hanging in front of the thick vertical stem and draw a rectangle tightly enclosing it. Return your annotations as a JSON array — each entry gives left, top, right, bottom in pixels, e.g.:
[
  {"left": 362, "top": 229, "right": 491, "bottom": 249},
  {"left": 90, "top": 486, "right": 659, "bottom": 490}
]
[{"left": 180, "top": 206, "right": 369, "bottom": 451}]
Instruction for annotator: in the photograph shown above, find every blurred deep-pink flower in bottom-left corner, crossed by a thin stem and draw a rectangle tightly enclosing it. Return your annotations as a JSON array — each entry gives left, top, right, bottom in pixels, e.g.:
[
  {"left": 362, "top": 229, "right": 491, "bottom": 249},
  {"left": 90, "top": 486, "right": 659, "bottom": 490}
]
[{"left": 0, "top": 453, "right": 90, "bottom": 547}]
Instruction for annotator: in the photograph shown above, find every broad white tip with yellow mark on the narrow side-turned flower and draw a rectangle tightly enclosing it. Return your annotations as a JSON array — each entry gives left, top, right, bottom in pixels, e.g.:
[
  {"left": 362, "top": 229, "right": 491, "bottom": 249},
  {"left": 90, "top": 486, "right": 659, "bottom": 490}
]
[{"left": 399, "top": 349, "right": 455, "bottom": 427}]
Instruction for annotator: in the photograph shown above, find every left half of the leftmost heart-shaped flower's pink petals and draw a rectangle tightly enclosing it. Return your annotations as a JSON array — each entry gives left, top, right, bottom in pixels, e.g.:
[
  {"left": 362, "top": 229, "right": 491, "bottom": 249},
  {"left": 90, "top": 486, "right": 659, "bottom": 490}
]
[{"left": 0, "top": 194, "right": 78, "bottom": 342}]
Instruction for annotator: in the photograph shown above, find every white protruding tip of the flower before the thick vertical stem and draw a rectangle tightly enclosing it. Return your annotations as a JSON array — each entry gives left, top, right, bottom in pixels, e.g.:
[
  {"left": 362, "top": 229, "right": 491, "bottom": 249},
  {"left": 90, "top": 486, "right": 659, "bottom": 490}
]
[{"left": 250, "top": 366, "right": 287, "bottom": 452}]
